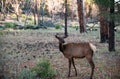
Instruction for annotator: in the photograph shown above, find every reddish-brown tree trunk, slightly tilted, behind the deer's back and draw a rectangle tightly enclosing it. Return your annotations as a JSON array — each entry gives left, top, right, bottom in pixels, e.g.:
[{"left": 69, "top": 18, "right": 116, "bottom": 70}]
[{"left": 77, "top": 0, "right": 85, "bottom": 33}]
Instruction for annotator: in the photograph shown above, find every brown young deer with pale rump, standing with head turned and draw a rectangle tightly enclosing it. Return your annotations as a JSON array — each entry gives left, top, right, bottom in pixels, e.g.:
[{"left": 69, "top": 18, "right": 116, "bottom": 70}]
[{"left": 55, "top": 35, "right": 96, "bottom": 79}]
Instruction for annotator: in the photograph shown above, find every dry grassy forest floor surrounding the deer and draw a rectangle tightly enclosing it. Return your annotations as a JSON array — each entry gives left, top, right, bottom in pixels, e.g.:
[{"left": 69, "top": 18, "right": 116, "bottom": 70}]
[{"left": 0, "top": 29, "right": 120, "bottom": 79}]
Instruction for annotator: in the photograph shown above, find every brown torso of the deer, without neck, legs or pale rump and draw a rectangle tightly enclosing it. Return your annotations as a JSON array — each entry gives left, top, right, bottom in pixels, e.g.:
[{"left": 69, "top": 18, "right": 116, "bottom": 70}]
[{"left": 63, "top": 42, "right": 93, "bottom": 58}]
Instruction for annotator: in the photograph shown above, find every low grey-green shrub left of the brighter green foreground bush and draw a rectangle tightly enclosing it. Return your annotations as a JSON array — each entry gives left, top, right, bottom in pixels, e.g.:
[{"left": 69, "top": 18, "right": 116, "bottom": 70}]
[{"left": 18, "top": 68, "right": 36, "bottom": 79}]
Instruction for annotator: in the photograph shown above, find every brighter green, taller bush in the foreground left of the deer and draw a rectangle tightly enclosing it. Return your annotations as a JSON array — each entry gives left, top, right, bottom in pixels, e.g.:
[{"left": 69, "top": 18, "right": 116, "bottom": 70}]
[{"left": 32, "top": 60, "right": 55, "bottom": 79}]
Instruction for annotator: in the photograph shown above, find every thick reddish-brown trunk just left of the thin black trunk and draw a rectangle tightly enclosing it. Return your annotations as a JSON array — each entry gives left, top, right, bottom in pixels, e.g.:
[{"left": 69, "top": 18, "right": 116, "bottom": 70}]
[{"left": 99, "top": 6, "right": 109, "bottom": 43}]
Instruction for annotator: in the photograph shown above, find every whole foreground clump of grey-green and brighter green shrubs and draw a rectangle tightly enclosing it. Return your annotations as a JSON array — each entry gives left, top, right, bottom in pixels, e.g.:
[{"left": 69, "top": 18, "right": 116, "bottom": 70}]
[{"left": 18, "top": 60, "right": 55, "bottom": 79}]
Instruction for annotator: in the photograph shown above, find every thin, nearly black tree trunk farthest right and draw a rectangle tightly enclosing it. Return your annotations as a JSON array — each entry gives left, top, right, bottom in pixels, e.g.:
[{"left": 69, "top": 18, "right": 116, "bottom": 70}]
[{"left": 109, "top": 0, "right": 115, "bottom": 51}]
